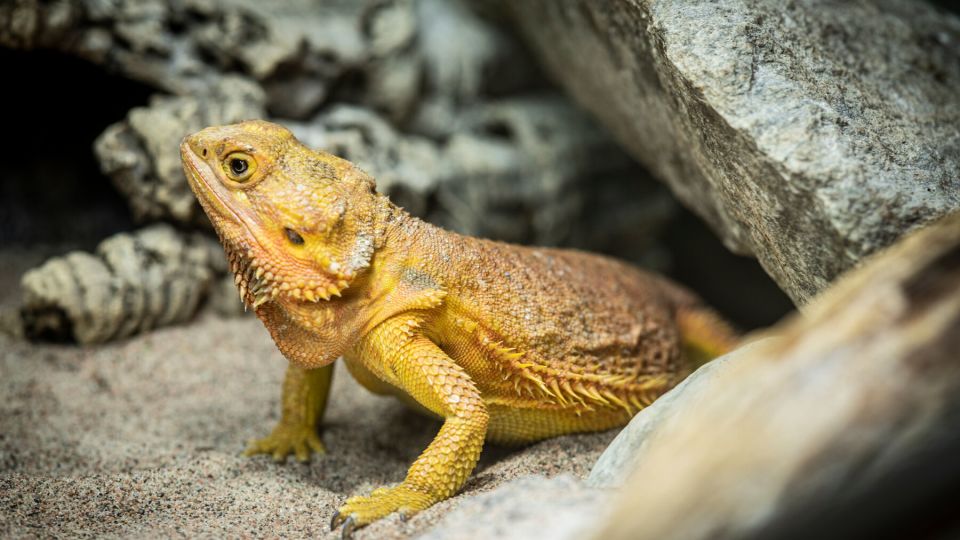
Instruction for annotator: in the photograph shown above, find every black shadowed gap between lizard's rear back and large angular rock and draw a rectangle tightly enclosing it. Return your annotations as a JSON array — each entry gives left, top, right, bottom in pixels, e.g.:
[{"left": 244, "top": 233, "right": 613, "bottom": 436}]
[{"left": 661, "top": 209, "right": 794, "bottom": 330}]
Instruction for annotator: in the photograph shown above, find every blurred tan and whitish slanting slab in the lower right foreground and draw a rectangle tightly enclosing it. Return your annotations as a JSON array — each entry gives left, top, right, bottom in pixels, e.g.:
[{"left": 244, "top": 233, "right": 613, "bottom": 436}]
[{"left": 591, "top": 213, "right": 960, "bottom": 540}]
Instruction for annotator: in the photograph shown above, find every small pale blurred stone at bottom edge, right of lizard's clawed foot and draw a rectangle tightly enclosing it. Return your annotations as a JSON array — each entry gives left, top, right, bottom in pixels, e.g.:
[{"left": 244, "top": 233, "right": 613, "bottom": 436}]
[{"left": 419, "top": 474, "right": 610, "bottom": 540}]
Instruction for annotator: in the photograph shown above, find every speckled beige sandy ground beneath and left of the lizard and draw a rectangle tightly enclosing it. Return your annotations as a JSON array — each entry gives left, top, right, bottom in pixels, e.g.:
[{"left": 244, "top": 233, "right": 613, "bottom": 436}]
[{"left": 0, "top": 315, "right": 614, "bottom": 539}]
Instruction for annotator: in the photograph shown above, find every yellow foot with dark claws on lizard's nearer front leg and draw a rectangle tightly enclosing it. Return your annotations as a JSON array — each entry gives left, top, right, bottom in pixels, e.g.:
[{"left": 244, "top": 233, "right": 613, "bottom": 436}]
[{"left": 330, "top": 484, "right": 437, "bottom": 538}]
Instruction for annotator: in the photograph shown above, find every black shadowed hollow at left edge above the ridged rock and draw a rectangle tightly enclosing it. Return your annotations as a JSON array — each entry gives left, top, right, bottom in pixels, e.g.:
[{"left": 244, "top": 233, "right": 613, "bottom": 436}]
[{"left": 0, "top": 49, "right": 153, "bottom": 249}]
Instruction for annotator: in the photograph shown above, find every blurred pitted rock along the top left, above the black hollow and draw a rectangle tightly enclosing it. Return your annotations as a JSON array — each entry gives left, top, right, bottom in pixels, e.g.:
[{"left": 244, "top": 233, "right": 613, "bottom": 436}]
[{"left": 0, "top": 0, "right": 408, "bottom": 118}]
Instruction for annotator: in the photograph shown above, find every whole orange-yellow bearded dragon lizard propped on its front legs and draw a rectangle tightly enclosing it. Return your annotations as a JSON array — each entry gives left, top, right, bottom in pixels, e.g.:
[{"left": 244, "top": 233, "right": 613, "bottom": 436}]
[{"left": 180, "top": 120, "right": 737, "bottom": 536}]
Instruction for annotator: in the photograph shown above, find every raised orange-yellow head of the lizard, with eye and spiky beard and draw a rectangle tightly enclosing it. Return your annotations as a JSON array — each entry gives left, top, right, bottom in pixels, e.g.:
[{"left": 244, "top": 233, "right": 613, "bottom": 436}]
[{"left": 180, "top": 121, "right": 376, "bottom": 308}]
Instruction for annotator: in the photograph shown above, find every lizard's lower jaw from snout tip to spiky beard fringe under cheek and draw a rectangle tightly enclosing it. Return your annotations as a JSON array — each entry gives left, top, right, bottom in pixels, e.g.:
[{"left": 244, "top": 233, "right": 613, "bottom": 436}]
[{"left": 180, "top": 141, "right": 350, "bottom": 310}]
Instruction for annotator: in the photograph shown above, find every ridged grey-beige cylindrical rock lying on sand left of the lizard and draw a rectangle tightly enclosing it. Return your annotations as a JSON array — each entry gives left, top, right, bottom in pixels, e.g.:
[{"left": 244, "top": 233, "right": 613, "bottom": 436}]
[{"left": 21, "top": 224, "right": 226, "bottom": 344}]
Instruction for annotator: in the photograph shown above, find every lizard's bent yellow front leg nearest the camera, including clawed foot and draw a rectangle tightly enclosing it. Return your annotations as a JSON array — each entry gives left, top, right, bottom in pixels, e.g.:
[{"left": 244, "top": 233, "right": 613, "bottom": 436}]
[{"left": 331, "top": 323, "right": 489, "bottom": 535}]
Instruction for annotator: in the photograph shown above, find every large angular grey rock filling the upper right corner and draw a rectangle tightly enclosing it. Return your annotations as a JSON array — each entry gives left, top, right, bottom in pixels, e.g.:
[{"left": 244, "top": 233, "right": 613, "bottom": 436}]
[{"left": 506, "top": 0, "right": 960, "bottom": 303}]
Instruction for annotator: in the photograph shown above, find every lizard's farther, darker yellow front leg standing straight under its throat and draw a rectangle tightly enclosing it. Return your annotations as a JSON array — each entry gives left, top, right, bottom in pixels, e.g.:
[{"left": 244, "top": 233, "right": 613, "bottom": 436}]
[{"left": 244, "top": 364, "right": 333, "bottom": 462}]
